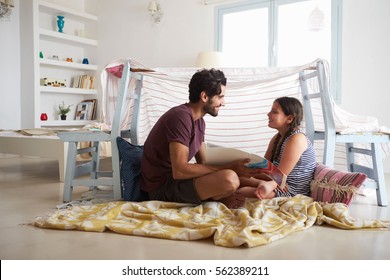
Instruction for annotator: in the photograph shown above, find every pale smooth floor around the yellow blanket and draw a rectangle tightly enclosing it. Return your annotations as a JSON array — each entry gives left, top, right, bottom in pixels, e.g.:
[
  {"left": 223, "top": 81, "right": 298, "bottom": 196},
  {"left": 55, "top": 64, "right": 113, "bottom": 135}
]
[{"left": 0, "top": 154, "right": 390, "bottom": 260}]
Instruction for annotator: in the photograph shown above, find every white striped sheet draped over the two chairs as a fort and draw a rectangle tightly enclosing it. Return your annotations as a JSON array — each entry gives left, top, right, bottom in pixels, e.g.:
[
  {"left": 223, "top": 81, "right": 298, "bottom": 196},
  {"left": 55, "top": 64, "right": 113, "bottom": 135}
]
[{"left": 102, "top": 59, "right": 389, "bottom": 169}]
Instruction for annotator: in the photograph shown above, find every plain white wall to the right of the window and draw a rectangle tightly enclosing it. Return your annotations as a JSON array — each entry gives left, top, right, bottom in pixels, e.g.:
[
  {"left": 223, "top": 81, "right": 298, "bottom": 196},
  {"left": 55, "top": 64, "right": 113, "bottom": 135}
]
[{"left": 341, "top": 0, "right": 390, "bottom": 127}]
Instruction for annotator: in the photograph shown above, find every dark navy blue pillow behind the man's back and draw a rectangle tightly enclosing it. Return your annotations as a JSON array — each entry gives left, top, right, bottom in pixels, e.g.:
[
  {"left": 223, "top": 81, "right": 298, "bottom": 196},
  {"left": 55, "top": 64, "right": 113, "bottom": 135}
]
[{"left": 116, "top": 137, "right": 148, "bottom": 201}]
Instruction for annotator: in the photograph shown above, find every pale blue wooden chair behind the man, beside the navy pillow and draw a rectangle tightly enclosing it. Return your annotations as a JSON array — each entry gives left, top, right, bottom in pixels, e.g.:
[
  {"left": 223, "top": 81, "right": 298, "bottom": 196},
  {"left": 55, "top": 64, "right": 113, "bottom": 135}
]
[{"left": 58, "top": 61, "right": 142, "bottom": 202}]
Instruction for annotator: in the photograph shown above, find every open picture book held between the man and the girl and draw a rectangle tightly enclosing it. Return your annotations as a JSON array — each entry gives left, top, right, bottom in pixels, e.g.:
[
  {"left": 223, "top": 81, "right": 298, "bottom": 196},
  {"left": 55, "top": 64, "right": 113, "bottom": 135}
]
[{"left": 206, "top": 146, "right": 287, "bottom": 190}]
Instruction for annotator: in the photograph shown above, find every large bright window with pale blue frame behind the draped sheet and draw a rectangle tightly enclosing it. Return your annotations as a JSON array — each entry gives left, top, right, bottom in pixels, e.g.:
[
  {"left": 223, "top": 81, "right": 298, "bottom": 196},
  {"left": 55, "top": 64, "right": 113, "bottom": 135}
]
[{"left": 216, "top": 0, "right": 341, "bottom": 100}]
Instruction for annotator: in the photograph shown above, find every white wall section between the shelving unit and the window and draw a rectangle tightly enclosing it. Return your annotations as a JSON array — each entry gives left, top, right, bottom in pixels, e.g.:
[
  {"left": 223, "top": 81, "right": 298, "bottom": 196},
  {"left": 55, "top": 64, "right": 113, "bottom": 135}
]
[{"left": 97, "top": 0, "right": 214, "bottom": 67}]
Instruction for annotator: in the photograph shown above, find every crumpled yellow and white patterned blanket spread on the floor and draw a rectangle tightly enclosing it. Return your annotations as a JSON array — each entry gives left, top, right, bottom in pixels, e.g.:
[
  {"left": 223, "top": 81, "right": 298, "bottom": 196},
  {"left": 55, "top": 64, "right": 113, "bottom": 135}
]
[{"left": 31, "top": 195, "right": 390, "bottom": 247}]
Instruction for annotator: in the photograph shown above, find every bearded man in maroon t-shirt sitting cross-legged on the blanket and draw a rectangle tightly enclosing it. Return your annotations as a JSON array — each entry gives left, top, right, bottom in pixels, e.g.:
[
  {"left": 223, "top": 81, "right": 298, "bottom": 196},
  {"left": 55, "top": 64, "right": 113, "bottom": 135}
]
[{"left": 141, "top": 69, "right": 254, "bottom": 208}]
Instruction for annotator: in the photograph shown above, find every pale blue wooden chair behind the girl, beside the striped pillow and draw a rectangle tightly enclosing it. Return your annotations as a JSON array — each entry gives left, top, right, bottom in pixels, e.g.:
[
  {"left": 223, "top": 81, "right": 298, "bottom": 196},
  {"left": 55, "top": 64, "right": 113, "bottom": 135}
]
[{"left": 300, "top": 60, "right": 390, "bottom": 206}]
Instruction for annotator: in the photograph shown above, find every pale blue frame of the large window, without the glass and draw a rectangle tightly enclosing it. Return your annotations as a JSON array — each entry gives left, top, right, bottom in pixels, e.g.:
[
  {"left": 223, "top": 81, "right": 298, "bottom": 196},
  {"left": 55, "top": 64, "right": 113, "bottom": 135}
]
[{"left": 214, "top": 0, "right": 342, "bottom": 102}]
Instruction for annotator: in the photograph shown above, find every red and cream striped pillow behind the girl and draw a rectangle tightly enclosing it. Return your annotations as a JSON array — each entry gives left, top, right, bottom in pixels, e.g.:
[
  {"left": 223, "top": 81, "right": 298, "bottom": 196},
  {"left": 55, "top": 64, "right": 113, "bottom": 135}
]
[{"left": 310, "top": 164, "right": 367, "bottom": 206}]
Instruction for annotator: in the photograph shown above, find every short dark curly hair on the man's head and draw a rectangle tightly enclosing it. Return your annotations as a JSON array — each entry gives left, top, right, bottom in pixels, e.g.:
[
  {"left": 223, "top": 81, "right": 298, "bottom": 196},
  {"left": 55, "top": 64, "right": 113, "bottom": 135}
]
[{"left": 188, "top": 68, "right": 226, "bottom": 103}]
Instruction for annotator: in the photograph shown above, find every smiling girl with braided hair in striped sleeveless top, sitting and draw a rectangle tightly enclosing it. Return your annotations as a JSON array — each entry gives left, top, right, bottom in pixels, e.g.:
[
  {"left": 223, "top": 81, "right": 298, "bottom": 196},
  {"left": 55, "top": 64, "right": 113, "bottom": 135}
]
[{"left": 237, "top": 97, "right": 317, "bottom": 199}]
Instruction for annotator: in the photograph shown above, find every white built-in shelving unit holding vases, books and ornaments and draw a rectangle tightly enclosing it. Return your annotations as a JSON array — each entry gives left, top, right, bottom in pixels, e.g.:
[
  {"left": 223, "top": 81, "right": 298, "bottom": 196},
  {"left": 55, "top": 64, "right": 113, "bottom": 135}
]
[{"left": 22, "top": 0, "right": 99, "bottom": 128}]
